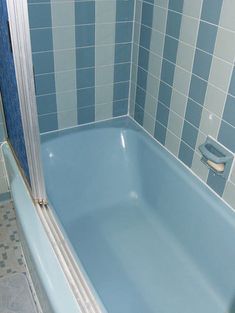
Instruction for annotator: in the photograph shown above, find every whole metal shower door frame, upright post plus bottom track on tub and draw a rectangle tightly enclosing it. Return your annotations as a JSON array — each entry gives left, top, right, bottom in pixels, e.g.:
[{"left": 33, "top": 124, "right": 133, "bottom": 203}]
[{"left": 6, "top": 0, "right": 106, "bottom": 313}]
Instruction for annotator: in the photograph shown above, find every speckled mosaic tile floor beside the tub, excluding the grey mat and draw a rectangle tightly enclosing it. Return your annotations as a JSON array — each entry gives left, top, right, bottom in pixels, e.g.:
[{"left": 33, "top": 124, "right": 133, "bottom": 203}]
[{"left": 0, "top": 200, "right": 41, "bottom": 313}]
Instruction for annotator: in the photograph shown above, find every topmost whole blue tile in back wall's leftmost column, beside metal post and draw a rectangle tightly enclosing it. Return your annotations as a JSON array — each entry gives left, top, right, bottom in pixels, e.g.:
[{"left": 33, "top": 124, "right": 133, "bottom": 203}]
[{"left": 28, "top": 3, "right": 51, "bottom": 28}]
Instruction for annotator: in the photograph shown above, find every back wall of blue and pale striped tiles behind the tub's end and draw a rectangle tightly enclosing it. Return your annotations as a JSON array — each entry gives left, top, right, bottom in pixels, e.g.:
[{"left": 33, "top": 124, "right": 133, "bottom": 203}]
[{"left": 28, "top": 0, "right": 134, "bottom": 132}]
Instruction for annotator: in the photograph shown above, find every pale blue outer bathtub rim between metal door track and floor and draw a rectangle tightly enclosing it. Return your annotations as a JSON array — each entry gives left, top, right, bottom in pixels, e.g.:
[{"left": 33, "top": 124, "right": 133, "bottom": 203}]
[{"left": 1, "top": 142, "right": 82, "bottom": 313}]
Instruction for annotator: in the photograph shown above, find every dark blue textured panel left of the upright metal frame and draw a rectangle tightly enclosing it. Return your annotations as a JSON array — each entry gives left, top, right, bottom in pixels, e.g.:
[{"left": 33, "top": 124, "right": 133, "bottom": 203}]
[{"left": 0, "top": 0, "right": 29, "bottom": 180}]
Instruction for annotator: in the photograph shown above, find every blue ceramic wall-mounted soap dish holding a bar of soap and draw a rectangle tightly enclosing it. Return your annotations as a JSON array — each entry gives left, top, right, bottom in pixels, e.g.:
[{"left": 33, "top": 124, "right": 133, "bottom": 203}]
[{"left": 199, "top": 137, "right": 233, "bottom": 179}]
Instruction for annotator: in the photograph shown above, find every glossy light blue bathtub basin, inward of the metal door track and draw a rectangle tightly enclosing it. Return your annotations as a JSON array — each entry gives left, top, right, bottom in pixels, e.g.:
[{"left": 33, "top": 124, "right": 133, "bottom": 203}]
[{"left": 41, "top": 117, "right": 235, "bottom": 313}]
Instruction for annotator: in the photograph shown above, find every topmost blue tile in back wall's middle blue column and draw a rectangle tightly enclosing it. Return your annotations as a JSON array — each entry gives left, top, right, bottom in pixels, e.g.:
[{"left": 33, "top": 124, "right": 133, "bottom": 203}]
[{"left": 75, "top": 1, "right": 95, "bottom": 25}]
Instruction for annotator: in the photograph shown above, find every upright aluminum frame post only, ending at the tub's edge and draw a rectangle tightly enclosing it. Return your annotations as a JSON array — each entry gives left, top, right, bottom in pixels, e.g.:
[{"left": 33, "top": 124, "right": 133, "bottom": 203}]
[{"left": 7, "top": 0, "right": 47, "bottom": 203}]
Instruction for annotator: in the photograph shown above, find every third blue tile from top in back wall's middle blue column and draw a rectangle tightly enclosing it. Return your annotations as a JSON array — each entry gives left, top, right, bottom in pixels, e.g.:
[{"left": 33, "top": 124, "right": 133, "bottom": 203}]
[{"left": 76, "top": 47, "right": 95, "bottom": 69}]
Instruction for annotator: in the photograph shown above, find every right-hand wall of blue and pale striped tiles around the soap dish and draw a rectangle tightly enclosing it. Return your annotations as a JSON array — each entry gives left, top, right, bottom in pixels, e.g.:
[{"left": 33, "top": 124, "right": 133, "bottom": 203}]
[{"left": 130, "top": 0, "right": 235, "bottom": 208}]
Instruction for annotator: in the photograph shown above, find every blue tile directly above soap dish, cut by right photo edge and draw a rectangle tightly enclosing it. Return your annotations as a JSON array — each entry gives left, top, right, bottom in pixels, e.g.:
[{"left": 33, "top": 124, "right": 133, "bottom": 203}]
[{"left": 218, "top": 120, "right": 235, "bottom": 152}]
